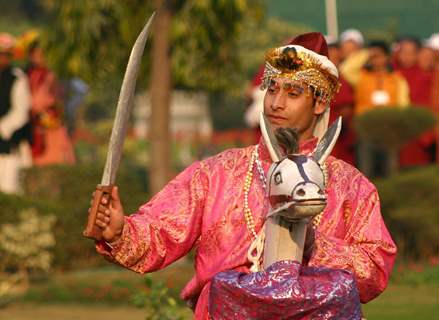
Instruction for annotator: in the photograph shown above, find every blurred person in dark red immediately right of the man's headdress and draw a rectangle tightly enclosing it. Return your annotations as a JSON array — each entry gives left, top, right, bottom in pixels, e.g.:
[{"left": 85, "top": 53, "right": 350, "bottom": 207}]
[{"left": 326, "top": 37, "right": 355, "bottom": 165}]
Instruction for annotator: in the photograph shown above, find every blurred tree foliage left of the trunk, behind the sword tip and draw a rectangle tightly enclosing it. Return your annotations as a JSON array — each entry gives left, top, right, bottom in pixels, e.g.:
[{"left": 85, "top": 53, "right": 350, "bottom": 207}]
[{"left": 42, "top": 0, "right": 144, "bottom": 83}]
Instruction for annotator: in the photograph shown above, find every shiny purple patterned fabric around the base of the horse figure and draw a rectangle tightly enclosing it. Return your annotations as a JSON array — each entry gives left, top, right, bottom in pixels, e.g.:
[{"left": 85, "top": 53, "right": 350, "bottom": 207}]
[{"left": 209, "top": 261, "right": 361, "bottom": 320}]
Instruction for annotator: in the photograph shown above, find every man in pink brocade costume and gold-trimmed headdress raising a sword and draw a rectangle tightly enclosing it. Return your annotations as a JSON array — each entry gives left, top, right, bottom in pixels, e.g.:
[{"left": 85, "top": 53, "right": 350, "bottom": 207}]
[{"left": 91, "top": 33, "right": 396, "bottom": 319}]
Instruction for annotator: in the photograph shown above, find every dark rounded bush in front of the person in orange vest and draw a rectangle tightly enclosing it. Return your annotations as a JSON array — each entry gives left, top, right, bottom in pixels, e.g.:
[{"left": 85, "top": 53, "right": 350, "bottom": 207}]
[{"left": 354, "top": 107, "right": 436, "bottom": 150}]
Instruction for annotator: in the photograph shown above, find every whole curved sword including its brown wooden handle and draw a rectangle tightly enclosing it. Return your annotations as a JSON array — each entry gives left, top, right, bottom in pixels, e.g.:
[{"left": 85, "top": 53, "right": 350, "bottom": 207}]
[{"left": 83, "top": 13, "right": 155, "bottom": 240}]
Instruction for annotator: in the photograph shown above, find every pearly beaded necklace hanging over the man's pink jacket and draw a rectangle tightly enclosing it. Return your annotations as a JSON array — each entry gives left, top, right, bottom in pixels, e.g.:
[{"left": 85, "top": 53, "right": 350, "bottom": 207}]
[{"left": 244, "top": 145, "right": 328, "bottom": 240}]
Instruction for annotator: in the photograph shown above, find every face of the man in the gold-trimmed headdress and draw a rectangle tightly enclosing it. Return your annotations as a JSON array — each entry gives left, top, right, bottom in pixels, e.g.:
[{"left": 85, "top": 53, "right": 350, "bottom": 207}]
[{"left": 264, "top": 78, "right": 326, "bottom": 140}]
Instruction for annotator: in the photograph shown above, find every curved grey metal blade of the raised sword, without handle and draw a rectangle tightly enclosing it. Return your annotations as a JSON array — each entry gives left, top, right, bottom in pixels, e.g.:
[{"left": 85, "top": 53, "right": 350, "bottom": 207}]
[{"left": 101, "top": 13, "right": 155, "bottom": 186}]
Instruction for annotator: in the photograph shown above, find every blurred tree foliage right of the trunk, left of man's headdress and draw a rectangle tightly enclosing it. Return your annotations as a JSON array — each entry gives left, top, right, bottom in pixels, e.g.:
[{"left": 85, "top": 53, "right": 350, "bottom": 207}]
[{"left": 170, "top": 0, "right": 264, "bottom": 90}]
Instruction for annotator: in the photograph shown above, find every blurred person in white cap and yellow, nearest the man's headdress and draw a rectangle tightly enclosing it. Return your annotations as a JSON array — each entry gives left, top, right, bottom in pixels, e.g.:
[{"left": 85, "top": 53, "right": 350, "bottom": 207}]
[{"left": 338, "top": 29, "right": 368, "bottom": 88}]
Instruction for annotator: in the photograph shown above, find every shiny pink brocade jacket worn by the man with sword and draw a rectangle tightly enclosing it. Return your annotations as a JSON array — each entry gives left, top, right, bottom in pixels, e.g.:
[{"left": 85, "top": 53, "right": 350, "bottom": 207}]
[{"left": 97, "top": 139, "right": 396, "bottom": 319}]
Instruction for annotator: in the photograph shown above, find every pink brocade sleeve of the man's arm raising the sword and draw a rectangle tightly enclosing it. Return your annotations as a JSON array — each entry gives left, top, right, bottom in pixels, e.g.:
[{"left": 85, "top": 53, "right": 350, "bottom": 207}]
[{"left": 96, "top": 162, "right": 208, "bottom": 273}]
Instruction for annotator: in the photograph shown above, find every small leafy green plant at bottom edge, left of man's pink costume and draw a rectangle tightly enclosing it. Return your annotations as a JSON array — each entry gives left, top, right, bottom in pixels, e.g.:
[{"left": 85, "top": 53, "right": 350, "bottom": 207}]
[{"left": 133, "top": 275, "right": 183, "bottom": 320}]
